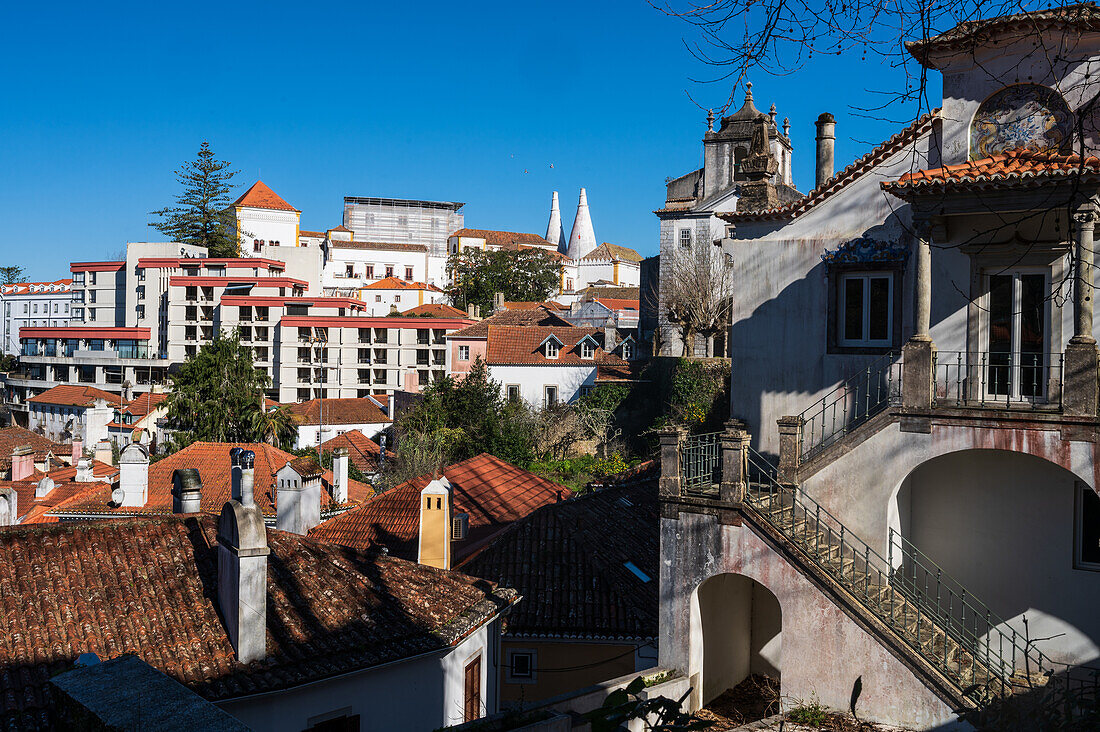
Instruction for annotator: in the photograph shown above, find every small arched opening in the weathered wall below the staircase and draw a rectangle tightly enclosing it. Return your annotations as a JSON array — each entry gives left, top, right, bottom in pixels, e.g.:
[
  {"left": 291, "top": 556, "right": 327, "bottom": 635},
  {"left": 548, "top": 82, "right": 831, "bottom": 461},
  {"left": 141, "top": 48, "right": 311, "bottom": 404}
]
[{"left": 692, "top": 573, "right": 783, "bottom": 706}]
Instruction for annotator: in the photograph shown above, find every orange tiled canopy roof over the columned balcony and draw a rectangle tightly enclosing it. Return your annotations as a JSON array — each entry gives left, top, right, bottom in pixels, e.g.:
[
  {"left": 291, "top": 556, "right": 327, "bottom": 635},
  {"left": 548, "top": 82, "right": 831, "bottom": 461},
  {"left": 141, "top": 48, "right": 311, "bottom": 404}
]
[{"left": 882, "top": 150, "right": 1100, "bottom": 195}]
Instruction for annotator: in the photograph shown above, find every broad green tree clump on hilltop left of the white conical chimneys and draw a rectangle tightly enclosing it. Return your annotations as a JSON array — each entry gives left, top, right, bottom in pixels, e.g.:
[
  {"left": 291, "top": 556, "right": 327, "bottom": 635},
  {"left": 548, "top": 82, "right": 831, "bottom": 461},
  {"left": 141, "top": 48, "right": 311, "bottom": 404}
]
[{"left": 447, "top": 249, "right": 561, "bottom": 315}]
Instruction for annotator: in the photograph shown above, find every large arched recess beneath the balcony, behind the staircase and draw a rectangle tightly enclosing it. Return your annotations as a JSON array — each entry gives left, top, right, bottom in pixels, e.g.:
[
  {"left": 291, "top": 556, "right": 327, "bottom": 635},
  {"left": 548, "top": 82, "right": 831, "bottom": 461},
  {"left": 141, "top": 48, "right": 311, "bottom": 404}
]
[{"left": 889, "top": 450, "right": 1100, "bottom": 665}]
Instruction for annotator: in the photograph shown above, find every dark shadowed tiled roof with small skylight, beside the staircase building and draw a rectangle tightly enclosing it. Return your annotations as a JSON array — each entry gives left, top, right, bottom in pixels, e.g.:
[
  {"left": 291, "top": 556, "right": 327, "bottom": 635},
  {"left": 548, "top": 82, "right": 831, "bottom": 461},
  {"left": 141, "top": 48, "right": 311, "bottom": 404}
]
[{"left": 462, "top": 477, "right": 660, "bottom": 641}]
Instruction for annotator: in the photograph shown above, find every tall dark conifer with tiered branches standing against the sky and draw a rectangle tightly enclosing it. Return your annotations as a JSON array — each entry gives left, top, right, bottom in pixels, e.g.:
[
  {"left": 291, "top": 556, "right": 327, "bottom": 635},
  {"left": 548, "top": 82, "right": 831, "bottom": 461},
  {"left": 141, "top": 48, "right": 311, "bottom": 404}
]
[{"left": 152, "top": 140, "right": 239, "bottom": 256}]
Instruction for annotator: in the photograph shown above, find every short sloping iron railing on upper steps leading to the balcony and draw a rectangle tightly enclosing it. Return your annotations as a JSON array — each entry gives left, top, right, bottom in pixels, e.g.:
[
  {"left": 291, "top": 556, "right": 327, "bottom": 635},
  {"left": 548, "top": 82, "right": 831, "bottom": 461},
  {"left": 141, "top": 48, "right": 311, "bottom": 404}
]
[{"left": 799, "top": 351, "right": 901, "bottom": 461}]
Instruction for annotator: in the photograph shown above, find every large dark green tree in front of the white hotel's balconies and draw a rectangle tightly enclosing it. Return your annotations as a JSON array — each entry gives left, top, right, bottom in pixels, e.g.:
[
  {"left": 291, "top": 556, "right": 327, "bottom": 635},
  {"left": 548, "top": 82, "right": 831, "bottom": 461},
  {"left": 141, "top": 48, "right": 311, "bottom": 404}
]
[{"left": 167, "top": 331, "right": 270, "bottom": 448}]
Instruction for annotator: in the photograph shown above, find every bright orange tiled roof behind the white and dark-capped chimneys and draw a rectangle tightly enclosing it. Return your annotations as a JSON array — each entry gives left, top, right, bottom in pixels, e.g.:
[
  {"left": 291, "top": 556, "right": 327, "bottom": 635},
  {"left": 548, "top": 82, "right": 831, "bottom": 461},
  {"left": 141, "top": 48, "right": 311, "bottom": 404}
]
[{"left": 55, "top": 443, "right": 374, "bottom": 516}]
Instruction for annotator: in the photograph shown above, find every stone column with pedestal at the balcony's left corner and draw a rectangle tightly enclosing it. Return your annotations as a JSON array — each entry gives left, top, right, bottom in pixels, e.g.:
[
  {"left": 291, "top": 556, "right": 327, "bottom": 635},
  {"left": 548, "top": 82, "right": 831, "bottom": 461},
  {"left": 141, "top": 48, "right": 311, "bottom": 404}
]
[{"left": 901, "top": 218, "right": 936, "bottom": 409}]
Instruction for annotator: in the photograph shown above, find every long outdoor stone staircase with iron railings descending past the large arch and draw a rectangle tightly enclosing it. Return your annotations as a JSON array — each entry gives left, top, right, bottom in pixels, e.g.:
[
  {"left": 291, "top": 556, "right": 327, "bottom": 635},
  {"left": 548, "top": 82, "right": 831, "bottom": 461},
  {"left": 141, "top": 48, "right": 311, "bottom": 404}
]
[{"left": 745, "top": 449, "right": 1053, "bottom": 703}]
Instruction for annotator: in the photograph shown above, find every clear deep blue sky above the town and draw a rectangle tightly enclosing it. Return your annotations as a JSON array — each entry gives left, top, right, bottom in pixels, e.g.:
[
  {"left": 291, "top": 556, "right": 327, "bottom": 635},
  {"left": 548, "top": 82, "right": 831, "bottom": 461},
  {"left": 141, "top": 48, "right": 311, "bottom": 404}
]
[{"left": 0, "top": 0, "right": 938, "bottom": 278}]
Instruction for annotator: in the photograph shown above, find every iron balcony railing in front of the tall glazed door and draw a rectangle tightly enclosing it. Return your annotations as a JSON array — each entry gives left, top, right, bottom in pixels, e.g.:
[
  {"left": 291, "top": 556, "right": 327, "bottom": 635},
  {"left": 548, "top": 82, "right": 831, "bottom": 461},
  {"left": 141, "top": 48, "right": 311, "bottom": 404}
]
[{"left": 933, "top": 351, "right": 1065, "bottom": 408}]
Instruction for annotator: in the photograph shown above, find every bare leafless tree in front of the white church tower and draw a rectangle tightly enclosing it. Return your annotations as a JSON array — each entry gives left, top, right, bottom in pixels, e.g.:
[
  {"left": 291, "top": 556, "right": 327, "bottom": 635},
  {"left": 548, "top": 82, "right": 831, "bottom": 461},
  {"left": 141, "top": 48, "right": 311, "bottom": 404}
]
[{"left": 661, "top": 243, "right": 733, "bottom": 356}]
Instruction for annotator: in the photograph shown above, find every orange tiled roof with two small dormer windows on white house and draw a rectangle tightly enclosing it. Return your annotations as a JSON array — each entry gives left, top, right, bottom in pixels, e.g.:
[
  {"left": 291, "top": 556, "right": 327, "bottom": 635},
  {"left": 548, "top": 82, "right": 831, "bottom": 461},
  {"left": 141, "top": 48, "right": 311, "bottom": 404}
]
[{"left": 485, "top": 325, "right": 625, "bottom": 367}]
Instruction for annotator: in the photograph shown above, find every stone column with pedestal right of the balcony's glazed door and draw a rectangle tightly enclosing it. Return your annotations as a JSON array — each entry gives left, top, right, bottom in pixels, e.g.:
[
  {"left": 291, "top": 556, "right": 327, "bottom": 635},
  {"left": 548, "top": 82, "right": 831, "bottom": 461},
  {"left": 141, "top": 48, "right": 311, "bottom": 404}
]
[{"left": 1062, "top": 205, "right": 1100, "bottom": 416}]
